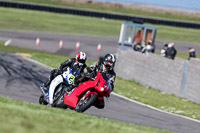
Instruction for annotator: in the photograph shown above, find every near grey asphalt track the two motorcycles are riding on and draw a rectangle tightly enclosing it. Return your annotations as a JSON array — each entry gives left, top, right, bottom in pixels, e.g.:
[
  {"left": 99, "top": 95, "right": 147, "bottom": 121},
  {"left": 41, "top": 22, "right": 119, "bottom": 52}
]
[{"left": 0, "top": 52, "right": 200, "bottom": 133}]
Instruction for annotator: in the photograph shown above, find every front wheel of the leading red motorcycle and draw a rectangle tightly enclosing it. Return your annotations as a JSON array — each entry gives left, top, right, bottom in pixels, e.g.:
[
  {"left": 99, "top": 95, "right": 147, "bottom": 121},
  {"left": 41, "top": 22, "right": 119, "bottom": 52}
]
[{"left": 75, "top": 93, "right": 97, "bottom": 112}]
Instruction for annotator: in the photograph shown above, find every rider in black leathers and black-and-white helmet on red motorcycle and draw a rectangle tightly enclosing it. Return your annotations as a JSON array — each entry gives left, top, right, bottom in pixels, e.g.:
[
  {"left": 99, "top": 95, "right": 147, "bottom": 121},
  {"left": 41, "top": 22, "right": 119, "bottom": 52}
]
[{"left": 85, "top": 54, "right": 116, "bottom": 109}]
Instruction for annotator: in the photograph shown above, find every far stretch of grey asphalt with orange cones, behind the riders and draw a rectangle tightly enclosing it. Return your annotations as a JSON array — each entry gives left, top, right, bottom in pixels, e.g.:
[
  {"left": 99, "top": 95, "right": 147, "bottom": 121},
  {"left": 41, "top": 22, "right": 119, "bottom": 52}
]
[{"left": 0, "top": 30, "right": 200, "bottom": 60}]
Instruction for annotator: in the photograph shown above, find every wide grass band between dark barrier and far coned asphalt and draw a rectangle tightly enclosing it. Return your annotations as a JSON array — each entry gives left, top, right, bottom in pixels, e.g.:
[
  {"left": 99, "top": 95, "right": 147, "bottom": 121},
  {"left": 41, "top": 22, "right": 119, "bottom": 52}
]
[{"left": 0, "top": 8, "right": 200, "bottom": 43}]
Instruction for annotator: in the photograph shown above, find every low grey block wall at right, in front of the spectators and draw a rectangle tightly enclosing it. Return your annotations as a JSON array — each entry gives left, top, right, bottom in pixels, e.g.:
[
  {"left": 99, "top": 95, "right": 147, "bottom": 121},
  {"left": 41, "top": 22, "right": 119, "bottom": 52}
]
[{"left": 115, "top": 49, "right": 200, "bottom": 103}]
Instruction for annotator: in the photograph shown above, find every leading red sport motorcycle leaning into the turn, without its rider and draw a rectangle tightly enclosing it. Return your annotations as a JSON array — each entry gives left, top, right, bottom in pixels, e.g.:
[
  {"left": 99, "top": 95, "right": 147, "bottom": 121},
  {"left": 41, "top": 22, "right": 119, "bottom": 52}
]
[{"left": 55, "top": 72, "right": 111, "bottom": 112}]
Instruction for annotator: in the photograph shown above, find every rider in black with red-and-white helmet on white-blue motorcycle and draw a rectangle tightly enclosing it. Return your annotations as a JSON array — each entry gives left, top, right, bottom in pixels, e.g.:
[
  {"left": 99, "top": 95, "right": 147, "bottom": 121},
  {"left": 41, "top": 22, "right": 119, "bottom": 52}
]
[{"left": 41, "top": 52, "right": 87, "bottom": 93}]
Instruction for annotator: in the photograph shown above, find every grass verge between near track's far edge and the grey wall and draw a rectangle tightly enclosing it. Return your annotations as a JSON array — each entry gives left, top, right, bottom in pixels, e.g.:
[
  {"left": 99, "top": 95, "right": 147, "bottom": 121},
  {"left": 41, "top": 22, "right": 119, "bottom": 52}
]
[{"left": 0, "top": 41, "right": 200, "bottom": 120}]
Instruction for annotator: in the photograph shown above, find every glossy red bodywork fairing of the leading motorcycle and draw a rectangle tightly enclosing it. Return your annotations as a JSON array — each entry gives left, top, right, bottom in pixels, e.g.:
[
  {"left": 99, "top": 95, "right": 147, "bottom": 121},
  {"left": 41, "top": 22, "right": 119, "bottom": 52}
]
[{"left": 64, "top": 72, "right": 111, "bottom": 108}]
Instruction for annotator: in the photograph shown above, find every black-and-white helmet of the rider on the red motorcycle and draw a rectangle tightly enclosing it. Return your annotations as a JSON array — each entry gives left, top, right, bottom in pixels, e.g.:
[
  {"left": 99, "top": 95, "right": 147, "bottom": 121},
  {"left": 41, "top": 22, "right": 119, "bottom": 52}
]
[{"left": 103, "top": 54, "right": 116, "bottom": 70}]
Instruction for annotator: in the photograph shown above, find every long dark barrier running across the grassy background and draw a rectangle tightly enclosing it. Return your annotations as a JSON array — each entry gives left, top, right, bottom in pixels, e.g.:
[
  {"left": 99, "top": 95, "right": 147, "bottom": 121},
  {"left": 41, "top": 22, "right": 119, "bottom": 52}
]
[{"left": 0, "top": 0, "right": 200, "bottom": 29}]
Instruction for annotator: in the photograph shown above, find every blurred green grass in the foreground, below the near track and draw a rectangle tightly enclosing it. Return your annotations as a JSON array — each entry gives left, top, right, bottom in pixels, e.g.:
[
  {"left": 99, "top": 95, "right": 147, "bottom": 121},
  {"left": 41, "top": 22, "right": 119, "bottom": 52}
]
[{"left": 0, "top": 97, "right": 172, "bottom": 133}]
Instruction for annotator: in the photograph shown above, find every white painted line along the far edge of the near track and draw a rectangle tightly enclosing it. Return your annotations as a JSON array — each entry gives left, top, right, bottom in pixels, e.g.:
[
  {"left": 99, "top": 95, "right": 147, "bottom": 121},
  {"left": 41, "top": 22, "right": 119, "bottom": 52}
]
[{"left": 18, "top": 53, "right": 200, "bottom": 123}]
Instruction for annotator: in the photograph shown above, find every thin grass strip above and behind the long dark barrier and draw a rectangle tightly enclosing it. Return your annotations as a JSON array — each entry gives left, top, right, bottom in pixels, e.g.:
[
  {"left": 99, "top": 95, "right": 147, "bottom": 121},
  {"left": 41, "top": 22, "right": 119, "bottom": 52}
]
[{"left": 7, "top": 0, "right": 200, "bottom": 22}]
